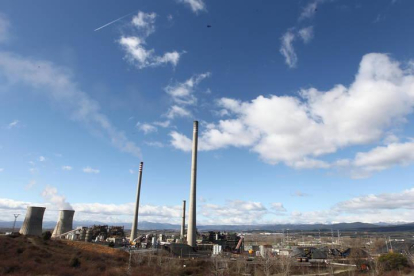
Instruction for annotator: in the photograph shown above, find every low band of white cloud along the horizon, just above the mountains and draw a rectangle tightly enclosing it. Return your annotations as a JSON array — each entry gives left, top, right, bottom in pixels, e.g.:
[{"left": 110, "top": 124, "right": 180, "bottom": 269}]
[{"left": 0, "top": 187, "right": 414, "bottom": 225}]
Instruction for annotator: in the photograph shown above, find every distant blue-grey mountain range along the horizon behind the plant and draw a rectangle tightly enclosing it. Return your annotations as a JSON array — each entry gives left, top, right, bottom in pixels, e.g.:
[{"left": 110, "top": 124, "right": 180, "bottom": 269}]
[{"left": 0, "top": 221, "right": 414, "bottom": 232}]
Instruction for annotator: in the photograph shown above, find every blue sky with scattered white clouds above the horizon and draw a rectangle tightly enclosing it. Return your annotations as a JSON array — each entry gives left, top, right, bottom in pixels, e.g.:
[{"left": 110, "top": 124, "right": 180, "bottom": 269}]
[{"left": 0, "top": 0, "right": 414, "bottom": 225}]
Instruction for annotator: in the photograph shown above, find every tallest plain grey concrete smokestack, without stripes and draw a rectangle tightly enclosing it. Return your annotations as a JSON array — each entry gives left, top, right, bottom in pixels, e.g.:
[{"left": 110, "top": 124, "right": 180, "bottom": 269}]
[{"left": 187, "top": 121, "right": 198, "bottom": 247}]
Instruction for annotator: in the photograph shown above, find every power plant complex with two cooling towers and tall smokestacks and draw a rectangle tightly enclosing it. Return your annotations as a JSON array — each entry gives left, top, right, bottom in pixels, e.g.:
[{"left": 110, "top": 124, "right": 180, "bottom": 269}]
[{"left": 13, "top": 121, "right": 243, "bottom": 256}]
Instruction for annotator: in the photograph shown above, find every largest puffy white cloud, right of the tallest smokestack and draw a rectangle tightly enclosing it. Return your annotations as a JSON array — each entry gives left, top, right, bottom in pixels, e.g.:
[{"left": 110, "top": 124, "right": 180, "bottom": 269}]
[{"left": 170, "top": 53, "right": 414, "bottom": 175}]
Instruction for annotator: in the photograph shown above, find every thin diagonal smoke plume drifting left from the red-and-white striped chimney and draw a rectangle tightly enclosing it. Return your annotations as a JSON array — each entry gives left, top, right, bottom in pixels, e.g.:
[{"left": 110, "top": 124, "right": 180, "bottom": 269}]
[{"left": 0, "top": 52, "right": 141, "bottom": 157}]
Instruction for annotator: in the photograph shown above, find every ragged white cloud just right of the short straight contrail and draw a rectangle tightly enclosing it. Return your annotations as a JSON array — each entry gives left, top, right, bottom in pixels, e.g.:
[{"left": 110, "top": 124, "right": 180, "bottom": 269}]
[{"left": 118, "top": 11, "right": 181, "bottom": 69}]
